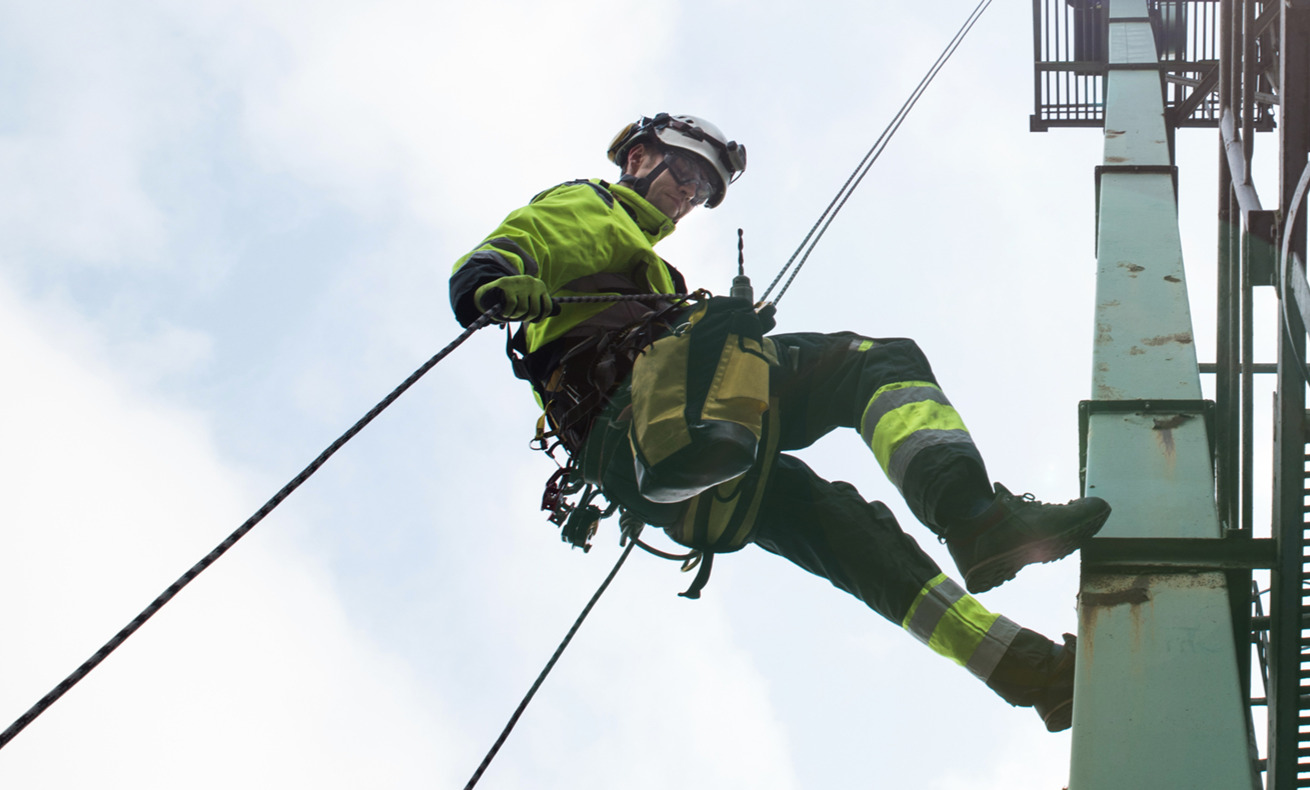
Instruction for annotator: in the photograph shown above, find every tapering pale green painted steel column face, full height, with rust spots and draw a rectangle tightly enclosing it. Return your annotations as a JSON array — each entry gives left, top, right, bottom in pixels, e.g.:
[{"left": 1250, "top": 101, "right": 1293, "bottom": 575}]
[{"left": 1069, "top": 0, "right": 1258, "bottom": 790}]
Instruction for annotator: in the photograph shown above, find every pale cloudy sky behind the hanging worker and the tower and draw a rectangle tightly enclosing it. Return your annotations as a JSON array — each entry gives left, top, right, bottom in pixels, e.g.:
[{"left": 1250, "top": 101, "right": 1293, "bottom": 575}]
[{"left": 0, "top": 0, "right": 1276, "bottom": 790}]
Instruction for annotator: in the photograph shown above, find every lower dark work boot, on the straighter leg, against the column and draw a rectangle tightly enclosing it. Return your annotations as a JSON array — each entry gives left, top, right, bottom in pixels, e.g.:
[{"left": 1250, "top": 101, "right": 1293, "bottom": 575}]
[{"left": 986, "top": 629, "right": 1078, "bottom": 732}]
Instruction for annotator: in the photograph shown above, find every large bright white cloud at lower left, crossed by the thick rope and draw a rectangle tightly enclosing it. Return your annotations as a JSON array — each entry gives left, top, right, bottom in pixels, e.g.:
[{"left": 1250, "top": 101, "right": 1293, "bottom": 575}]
[{"left": 0, "top": 275, "right": 459, "bottom": 787}]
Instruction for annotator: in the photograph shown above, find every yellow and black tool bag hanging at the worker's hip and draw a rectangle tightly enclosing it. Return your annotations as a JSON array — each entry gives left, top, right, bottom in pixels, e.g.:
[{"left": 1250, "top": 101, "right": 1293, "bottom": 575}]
[{"left": 629, "top": 297, "right": 777, "bottom": 502}]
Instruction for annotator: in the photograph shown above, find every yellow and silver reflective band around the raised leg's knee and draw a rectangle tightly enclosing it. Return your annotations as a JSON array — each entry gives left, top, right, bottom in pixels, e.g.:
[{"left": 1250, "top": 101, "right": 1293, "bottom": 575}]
[{"left": 859, "top": 381, "right": 973, "bottom": 487}]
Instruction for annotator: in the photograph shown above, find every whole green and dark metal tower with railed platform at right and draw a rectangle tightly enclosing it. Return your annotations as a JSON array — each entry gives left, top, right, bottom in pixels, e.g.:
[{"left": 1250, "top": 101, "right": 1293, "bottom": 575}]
[{"left": 1031, "top": 0, "right": 1310, "bottom": 790}]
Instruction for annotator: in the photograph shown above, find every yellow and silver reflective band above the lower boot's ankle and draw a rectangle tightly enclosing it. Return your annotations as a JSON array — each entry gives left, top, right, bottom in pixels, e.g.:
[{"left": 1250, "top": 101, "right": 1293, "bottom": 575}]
[{"left": 901, "top": 574, "right": 1019, "bottom": 680}]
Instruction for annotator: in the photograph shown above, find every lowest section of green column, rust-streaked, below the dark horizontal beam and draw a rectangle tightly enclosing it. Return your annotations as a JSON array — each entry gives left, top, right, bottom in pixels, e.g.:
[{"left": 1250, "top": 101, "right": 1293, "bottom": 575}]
[{"left": 1069, "top": 573, "right": 1252, "bottom": 790}]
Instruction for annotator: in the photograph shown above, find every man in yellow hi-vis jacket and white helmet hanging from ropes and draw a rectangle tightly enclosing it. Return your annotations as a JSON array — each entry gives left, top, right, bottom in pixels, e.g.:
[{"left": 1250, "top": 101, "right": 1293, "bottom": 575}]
[{"left": 451, "top": 114, "right": 1110, "bottom": 731}]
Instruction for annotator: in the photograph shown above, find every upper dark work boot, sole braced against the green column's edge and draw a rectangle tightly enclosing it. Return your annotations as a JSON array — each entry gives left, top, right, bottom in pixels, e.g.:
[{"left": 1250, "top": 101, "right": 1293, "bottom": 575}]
[{"left": 946, "top": 483, "right": 1110, "bottom": 593}]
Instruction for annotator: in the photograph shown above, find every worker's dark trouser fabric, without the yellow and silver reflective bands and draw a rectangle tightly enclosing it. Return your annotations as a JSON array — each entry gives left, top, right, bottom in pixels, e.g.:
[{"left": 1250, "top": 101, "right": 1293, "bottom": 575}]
[{"left": 752, "top": 333, "right": 990, "bottom": 625}]
